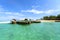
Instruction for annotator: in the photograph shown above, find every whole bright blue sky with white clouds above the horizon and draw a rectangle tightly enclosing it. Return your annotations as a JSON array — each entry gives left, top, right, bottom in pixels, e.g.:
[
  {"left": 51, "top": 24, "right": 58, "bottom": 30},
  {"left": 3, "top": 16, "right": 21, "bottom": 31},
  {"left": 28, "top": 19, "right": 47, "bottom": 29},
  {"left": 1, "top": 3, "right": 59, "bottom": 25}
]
[{"left": 0, "top": 0, "right": 60, "bottom": 20}]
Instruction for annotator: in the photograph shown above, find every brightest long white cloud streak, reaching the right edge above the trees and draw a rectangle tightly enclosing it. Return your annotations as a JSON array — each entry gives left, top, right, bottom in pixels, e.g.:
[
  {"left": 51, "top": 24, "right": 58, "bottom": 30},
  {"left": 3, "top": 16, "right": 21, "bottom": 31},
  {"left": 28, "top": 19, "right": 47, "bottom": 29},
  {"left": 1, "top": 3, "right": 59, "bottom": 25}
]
[{"left": 21, "top": 9, "right": 60, "bottom": 14}]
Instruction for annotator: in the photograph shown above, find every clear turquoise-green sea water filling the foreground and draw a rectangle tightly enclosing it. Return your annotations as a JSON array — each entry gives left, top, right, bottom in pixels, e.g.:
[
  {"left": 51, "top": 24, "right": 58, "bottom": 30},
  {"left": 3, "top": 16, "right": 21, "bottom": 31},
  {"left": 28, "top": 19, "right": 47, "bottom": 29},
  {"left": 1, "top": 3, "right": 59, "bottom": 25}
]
[{"left": 0, "top": 22, "right": 60, "bottom": 40}]
